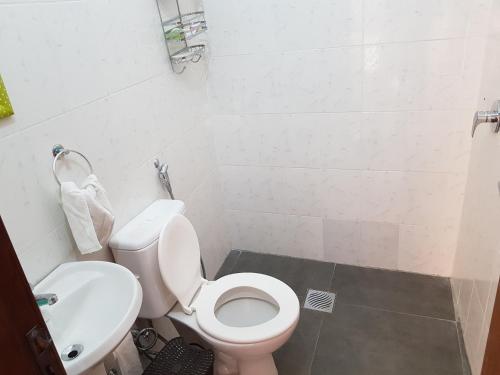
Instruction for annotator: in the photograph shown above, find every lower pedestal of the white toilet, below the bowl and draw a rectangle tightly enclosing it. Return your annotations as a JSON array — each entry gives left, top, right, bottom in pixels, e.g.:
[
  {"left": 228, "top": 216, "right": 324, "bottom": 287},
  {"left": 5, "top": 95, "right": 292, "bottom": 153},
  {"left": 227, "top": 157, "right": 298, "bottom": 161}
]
[{"left": 214, "top": 352, "right": 278, "bottom": 375}]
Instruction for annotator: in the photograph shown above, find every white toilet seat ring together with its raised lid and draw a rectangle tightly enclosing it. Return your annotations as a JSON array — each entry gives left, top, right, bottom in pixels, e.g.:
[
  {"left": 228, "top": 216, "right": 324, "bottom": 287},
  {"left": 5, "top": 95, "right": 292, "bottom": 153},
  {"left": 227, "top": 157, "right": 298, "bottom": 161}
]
[{"left": 158, "top": 214, "right": 300, "bottom": 344}]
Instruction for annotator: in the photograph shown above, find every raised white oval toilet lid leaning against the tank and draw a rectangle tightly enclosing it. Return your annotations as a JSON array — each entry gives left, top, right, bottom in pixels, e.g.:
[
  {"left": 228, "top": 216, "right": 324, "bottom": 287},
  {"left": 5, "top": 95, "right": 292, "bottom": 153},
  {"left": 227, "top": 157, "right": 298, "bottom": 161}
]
[{"left": 158, "top": 214, "right": 203, "bottom": 311}]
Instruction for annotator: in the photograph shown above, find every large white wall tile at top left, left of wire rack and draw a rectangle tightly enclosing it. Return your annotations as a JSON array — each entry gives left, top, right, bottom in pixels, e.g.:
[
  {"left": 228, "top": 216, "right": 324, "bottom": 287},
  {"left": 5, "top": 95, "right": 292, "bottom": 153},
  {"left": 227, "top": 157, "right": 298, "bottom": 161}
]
[{"left": 0, "top": 0, "right": 166, "bottom": 140}]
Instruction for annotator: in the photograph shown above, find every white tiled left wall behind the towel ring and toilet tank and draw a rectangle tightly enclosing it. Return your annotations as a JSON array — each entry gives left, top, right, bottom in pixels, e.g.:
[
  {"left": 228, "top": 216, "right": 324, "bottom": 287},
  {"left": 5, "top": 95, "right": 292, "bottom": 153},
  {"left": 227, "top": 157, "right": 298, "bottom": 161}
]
[{"left": 0, "top": 0, "right": 228, "bottom": 282}]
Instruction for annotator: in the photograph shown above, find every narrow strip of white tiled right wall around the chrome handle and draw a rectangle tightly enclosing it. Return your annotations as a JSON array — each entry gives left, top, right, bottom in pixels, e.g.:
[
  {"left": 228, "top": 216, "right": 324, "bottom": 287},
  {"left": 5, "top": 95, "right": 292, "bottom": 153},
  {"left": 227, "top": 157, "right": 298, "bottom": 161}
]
[{"left": 452, "top": 0, "right": 500, "bottom": 375}]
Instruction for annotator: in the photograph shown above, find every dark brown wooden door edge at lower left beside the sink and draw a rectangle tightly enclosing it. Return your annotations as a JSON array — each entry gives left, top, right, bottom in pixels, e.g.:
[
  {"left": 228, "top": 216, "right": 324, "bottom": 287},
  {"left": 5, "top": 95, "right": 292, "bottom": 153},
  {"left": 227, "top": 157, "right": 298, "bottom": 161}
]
[{"left": 0, "top": 218, "right": 66, "bottom": 375}]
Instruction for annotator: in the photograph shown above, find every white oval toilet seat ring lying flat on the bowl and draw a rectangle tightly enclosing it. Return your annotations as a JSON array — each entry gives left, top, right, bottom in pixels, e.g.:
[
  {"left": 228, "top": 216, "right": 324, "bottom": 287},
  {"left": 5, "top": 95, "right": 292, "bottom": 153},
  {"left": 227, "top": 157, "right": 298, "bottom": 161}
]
[{"left": 195, "top": 273, "right": 300, "bottom": 344}]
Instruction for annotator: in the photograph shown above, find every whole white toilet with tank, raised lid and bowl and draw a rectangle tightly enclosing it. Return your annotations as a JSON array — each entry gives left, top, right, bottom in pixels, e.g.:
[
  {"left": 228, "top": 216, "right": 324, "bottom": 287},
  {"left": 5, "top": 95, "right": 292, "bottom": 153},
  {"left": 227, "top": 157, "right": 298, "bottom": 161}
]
[{"left": 110, "top": 200, "right": 300, "bottom": 375}]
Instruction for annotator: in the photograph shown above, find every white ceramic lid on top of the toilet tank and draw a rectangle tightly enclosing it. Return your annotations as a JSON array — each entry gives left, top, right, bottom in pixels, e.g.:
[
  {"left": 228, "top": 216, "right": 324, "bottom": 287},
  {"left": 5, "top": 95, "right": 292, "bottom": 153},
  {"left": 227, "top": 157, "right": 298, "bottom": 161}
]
[{"left": 109, "top": 199, "right": 185, "bottom": 251}]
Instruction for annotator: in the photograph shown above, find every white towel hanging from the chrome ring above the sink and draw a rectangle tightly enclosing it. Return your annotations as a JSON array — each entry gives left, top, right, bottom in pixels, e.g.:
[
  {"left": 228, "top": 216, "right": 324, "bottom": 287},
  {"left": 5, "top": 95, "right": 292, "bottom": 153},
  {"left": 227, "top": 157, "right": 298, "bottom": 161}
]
[{"left": 61, "top": 174, "right": 115, "bottom": 254}]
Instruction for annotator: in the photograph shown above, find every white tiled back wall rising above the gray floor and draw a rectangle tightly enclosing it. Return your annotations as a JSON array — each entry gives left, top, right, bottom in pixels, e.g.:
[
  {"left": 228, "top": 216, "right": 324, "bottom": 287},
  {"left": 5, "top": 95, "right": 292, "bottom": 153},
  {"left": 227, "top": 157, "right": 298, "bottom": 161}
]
[{"left": 205, "top": 0, "right": 490, "bottom": 275}]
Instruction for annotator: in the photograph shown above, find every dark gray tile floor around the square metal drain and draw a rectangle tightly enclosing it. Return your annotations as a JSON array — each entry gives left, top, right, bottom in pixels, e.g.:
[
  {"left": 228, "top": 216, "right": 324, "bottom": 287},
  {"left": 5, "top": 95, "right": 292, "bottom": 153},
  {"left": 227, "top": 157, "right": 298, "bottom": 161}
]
[{"left": 217, "top": 251, "right": 469, "bottom": 375}]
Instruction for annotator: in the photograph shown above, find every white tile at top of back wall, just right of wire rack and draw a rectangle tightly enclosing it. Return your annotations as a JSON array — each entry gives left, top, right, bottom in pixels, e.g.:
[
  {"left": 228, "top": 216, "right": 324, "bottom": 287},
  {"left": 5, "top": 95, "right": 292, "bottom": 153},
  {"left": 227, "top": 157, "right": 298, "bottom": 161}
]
[{"left": 205, "top": 0, "right": 363, "bottom": 56}]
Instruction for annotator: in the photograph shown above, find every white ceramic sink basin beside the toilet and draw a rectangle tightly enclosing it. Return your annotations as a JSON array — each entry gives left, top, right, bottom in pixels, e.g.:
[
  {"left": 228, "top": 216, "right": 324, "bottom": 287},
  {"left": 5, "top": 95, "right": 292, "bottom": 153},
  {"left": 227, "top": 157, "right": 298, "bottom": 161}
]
[{"left": 33, "top": 261, "right": 142, "bottom": 375}]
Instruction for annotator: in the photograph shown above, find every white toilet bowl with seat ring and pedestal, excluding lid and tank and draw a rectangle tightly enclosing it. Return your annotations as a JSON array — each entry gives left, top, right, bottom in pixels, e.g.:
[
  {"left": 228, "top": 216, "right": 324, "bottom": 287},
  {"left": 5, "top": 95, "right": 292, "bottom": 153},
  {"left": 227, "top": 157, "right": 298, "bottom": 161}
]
[{"left": 167, "top": 273, "right": 299, "bottom": 375}]
